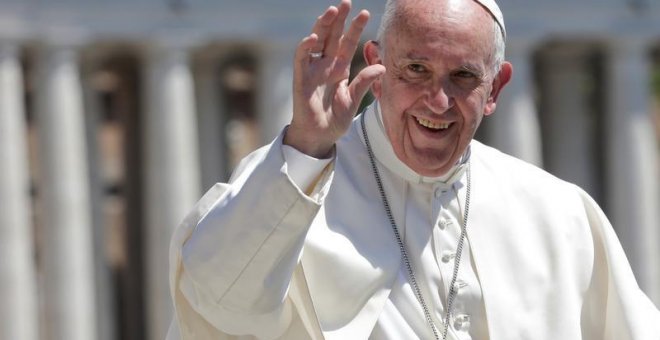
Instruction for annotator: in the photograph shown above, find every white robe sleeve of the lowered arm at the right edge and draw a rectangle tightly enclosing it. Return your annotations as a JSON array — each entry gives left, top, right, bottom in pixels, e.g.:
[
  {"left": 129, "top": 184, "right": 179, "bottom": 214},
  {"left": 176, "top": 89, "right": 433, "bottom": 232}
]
[{"left": 580, "top": 190, "right": 660, "bottom": 340}]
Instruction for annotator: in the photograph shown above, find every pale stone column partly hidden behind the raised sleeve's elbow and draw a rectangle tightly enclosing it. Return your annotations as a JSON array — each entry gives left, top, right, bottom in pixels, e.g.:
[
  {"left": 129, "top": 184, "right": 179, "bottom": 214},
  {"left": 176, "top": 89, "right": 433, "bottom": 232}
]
[{"left": 143, "top": 43, "right": 200, "bottom": 340}]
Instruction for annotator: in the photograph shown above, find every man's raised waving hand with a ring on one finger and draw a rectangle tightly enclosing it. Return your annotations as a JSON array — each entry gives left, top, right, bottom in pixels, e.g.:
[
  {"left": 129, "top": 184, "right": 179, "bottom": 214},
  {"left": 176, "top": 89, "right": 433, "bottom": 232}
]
[{"left": 284, "top": 0, "right": 385, "bottom": 158}]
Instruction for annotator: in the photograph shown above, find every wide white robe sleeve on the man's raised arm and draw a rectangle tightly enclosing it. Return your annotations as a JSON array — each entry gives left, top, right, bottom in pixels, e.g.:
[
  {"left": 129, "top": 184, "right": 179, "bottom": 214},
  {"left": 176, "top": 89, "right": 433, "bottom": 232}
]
[{"left": 168, "top": 131, "right": 332, "bottom": 339}]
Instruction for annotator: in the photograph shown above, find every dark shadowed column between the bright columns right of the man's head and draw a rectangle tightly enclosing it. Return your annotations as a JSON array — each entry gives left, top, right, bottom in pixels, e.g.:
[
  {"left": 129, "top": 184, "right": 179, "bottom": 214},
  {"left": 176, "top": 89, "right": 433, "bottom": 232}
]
[{"left": 541, "top": 45, "right": 602, "bottom": 199}]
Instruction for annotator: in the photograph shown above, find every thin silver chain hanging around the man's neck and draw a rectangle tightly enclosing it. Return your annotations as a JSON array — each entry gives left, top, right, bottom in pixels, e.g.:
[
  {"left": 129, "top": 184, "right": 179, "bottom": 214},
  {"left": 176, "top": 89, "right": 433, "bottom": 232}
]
[{"left": 360, "top": 113, "right": 472, "bottom": 340}]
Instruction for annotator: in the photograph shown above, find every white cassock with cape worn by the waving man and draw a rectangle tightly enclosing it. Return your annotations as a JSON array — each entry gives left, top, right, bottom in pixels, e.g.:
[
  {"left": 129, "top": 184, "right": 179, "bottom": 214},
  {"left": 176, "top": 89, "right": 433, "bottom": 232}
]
[{"left": 168, "top": 105, "right": 660, "bottom": 340}]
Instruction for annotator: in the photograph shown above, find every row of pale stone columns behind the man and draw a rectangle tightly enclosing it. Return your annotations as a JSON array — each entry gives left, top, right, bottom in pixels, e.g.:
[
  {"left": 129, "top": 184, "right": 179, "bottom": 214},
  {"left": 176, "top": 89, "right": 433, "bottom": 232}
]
[{"left": 0, "top": 33, "right": 660, "bottom": 340}]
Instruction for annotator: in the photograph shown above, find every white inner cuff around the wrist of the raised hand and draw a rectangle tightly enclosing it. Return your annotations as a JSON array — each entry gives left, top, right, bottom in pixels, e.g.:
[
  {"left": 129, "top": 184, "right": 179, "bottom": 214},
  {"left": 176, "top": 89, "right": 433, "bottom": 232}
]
[{"left": 282, "top": 145, "right": 334, "bottom": 191}]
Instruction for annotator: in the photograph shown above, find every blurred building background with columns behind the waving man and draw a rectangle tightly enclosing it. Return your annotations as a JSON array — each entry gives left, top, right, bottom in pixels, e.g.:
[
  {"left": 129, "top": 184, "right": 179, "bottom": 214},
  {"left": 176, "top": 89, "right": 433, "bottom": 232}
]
[{"left": 0, "top": 0, "right": 660, "bottom": 340}]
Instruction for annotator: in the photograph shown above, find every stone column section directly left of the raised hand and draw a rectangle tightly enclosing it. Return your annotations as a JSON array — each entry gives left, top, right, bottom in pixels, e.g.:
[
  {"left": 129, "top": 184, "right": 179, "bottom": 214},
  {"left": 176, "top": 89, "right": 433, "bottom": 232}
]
[{"left": 258, "top": 41, "right": 296, "bottom": 144}]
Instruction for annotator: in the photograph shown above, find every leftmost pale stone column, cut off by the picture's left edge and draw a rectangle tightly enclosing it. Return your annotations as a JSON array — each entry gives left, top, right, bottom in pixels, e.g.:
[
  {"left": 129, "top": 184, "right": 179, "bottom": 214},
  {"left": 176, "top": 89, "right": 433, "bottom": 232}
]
[{"left": 0, "top": 46, "right": 39, "bottom": 340}]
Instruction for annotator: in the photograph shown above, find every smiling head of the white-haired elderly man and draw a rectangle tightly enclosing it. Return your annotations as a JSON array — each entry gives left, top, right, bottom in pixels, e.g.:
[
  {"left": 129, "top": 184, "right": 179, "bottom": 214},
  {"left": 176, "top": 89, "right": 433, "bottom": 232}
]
[{"left": 365, "top": 1, "right": 511, "bottom": 176}]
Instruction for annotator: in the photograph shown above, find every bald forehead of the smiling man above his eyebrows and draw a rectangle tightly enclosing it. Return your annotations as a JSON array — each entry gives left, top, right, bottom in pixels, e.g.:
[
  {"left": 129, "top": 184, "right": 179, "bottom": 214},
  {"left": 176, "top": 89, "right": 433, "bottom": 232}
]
[{"left": 385, "top": 0, "right": 494, "bottom": 63}]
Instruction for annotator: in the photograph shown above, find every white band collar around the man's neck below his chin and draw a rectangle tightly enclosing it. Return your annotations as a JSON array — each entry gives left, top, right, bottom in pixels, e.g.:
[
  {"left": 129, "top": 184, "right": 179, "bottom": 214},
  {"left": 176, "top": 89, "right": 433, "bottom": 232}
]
[{"left": 363, "top": 101, "right": 470, "bottom": 185}]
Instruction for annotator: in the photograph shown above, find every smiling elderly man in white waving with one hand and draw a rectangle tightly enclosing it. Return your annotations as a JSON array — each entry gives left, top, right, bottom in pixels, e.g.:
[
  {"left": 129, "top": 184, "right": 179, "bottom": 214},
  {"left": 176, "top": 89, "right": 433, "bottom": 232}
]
[{"left": 170, "top": 0, "right": 660, "bottom": 340}]
